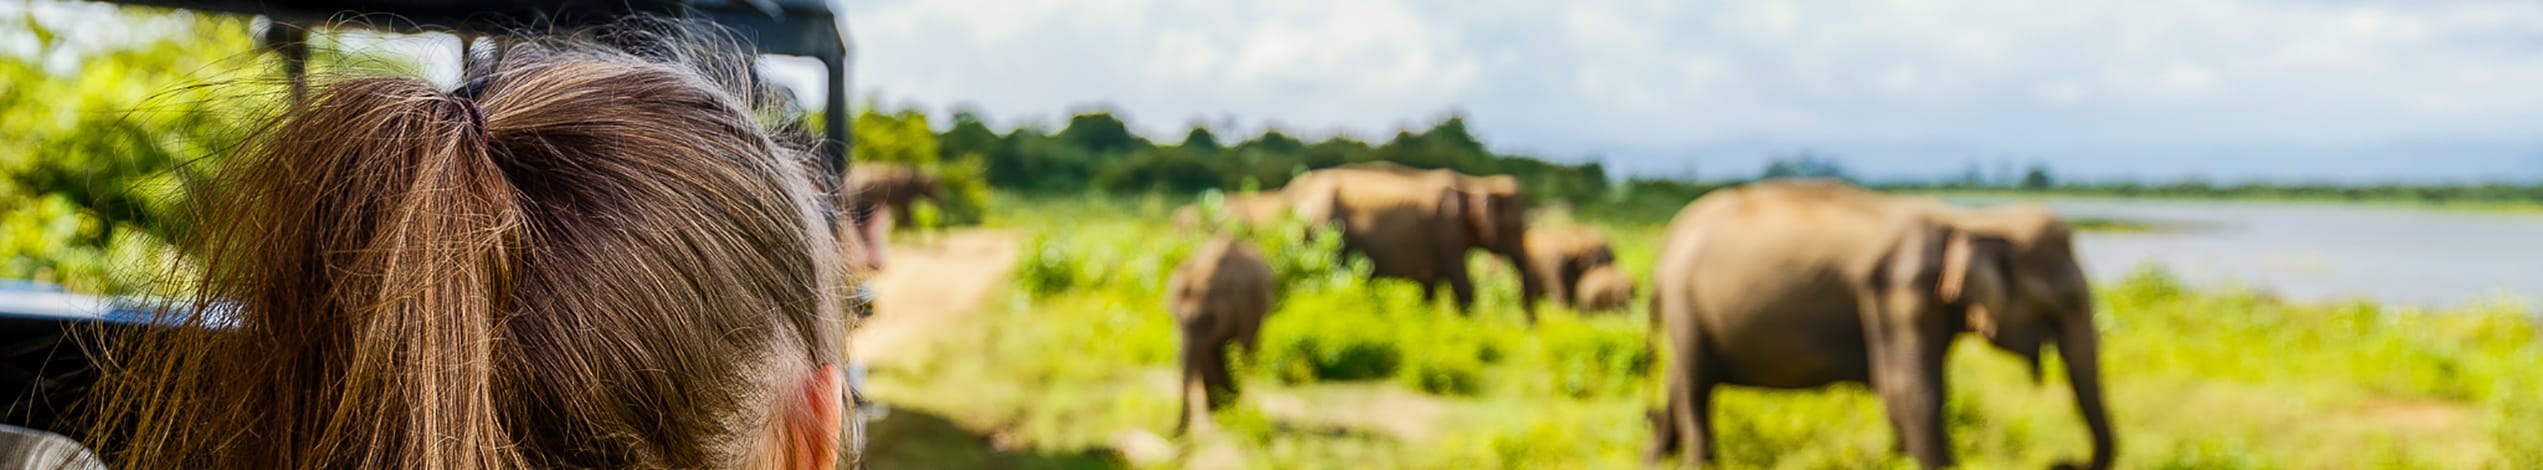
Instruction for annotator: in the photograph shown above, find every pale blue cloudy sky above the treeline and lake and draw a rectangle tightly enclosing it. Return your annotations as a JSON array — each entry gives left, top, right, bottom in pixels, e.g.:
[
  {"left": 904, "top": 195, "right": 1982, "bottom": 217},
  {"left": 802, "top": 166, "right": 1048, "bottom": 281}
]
[{"left": 803, "top": 0, "right": 2543, "bottom": 180}]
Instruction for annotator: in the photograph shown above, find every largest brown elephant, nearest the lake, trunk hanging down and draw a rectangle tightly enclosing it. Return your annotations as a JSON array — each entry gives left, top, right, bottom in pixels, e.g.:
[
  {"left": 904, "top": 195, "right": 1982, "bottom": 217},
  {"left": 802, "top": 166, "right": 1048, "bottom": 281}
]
[{"left": 1645, "top": 180, "right": 2118, "bottom": 467}]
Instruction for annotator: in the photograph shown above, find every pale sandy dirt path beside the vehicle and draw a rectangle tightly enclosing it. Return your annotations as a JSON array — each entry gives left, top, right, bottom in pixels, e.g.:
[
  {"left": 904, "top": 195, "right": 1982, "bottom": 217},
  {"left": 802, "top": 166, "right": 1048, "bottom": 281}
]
[{"left": 849, "top": 229, "right": 1017, "bottom": 366}]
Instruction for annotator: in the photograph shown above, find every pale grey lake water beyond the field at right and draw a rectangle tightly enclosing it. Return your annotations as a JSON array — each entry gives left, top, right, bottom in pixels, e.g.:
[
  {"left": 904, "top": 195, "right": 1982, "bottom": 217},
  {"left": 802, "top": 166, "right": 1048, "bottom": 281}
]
[{"left": 1953, "top": 198, "right": 2543, "bottom": 307}]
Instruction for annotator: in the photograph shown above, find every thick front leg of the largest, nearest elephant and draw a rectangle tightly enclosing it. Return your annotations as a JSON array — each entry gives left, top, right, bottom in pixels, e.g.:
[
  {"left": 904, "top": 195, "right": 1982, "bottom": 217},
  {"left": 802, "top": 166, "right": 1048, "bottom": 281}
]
[{"left": 1867, "top": 293, "right": 1953, "bottom": 467}]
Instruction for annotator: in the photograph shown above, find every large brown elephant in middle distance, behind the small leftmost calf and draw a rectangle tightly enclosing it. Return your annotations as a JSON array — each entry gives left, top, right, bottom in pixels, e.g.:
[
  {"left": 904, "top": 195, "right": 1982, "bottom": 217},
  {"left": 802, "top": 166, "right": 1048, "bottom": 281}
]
[{"left": 1282, "top": 163, "right": 1544, "bottom": 323}]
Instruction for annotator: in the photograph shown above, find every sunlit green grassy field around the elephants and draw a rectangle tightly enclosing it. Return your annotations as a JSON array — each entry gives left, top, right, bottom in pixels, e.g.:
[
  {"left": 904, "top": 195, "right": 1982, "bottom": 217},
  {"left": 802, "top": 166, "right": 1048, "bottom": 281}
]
[{"left": 872, "top": 198, "right": 2543, "bottom": 467}]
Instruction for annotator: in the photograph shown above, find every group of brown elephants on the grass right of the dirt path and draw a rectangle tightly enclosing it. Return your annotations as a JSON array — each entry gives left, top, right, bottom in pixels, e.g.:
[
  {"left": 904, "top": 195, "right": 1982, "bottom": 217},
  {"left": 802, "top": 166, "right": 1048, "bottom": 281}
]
[{"left": 1167, "top": 163, "right": 2116, "bottom": 467}]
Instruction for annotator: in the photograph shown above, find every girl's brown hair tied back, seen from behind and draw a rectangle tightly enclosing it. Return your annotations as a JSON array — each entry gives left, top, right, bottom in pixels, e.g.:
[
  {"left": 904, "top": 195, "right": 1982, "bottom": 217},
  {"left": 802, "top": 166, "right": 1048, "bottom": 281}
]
[{"left": 89, "top": 31, "right": 847, "bottom": 467}]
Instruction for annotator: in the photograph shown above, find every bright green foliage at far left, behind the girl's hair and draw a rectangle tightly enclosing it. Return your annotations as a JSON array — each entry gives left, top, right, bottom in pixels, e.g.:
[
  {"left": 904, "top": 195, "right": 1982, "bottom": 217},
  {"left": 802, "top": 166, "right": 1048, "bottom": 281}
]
[{"left": 0, "top": 3, "right": 279, "bottom": 292}]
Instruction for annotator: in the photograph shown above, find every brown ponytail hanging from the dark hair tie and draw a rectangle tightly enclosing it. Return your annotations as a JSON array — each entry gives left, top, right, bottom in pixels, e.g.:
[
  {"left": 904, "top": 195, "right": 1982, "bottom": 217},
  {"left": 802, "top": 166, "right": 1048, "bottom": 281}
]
[{"left": 109, "top": 79, "right": 524, "bottom": 467}]
